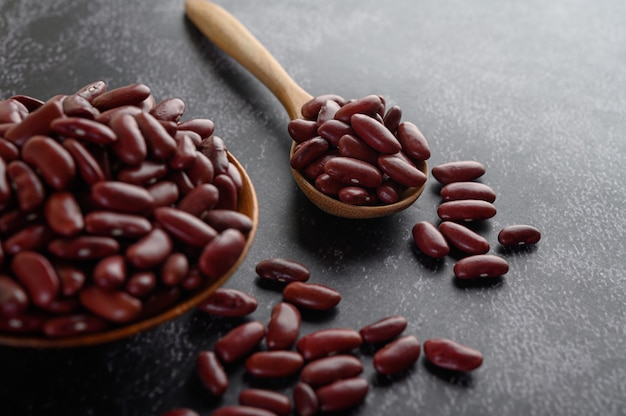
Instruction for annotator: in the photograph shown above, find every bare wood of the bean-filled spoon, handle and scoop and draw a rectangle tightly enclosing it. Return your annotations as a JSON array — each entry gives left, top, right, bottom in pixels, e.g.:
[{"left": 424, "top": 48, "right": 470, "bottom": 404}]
[{"left": 185, "top": 0, "right": 428, "bottom": 219}]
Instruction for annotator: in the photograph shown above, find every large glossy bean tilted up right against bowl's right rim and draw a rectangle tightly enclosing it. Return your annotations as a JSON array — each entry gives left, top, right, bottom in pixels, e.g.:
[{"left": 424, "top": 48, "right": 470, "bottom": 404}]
[{"left": 198, "top": 228, "right": 246, "bottom": 278}]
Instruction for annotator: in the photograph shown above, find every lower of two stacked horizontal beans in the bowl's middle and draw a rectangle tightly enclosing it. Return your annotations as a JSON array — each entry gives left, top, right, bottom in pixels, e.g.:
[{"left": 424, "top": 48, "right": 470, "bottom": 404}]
[{"left": 85, "top": 211, "right": 152, "bottom": 238}]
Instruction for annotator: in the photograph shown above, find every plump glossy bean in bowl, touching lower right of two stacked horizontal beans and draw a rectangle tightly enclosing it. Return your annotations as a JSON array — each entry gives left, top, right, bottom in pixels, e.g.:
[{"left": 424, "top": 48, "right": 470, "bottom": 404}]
[{"left": 125, "top": 228, "right": 173, "bottom": 269}]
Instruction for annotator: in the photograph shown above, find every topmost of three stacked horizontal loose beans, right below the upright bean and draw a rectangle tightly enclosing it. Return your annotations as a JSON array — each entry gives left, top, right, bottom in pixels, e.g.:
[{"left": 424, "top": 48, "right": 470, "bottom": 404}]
[{"left": 296, "top": 328, "right": 363, "bottom": 361}]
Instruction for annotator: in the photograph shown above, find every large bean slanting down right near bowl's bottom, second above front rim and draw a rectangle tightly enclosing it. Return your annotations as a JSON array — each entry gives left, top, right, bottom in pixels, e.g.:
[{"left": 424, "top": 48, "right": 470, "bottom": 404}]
[{"left": 78, "top": 286, "right": 142, "bottom": 324}]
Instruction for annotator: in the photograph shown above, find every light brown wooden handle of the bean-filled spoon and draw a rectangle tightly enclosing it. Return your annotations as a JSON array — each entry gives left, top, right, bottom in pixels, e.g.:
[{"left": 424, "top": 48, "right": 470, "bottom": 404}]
[{"left": 185, "top": 0, "right": 313, "bottom": 120}]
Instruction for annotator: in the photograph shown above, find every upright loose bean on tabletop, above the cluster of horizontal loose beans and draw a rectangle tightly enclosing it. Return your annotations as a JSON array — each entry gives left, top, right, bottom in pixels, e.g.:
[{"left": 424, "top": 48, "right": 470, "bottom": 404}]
[{"left": 265, "top": 302, "right": 302, "bottom": 351}]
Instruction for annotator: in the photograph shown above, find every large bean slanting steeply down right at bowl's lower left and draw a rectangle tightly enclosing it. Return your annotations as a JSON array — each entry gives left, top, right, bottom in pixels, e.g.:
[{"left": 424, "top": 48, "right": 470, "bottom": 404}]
[{"left": 11, "top": 251, "right": 60, "bottom": 307}]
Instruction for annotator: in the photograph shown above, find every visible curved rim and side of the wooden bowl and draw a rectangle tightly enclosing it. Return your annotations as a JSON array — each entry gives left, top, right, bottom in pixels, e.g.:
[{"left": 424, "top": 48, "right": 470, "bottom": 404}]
[{"left": 0, "top": 153, "right": 259, "bottom": 348}]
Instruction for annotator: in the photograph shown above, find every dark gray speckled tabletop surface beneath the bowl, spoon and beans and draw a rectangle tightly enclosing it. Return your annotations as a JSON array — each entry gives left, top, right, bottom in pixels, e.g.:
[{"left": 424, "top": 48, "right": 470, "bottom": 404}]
[{"left": 0, "top": 0, "right": 626, "bottom": 416}]
